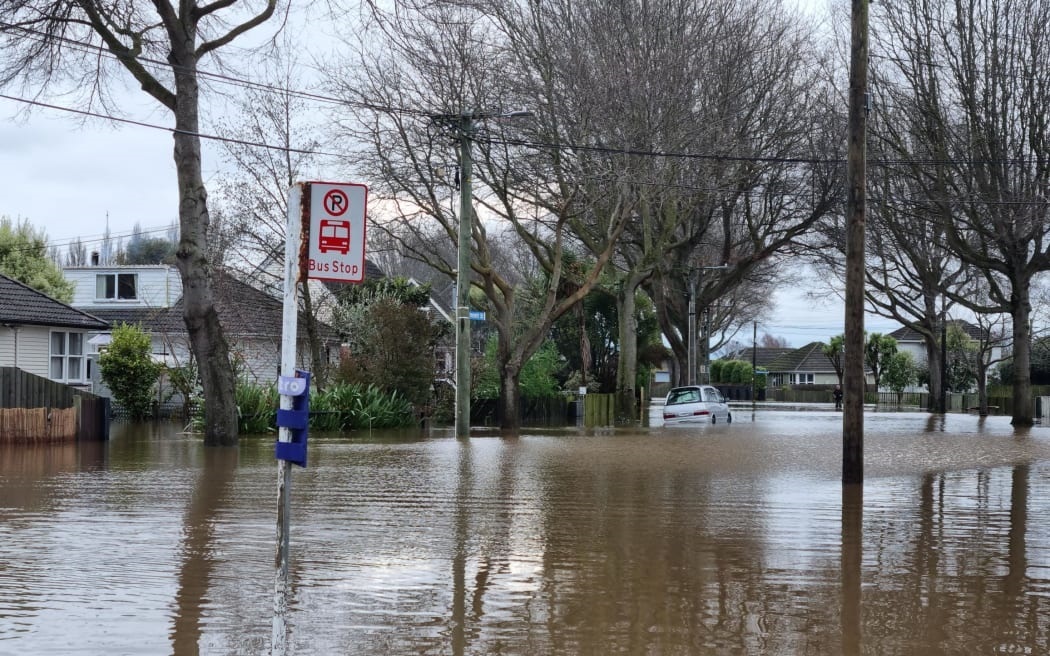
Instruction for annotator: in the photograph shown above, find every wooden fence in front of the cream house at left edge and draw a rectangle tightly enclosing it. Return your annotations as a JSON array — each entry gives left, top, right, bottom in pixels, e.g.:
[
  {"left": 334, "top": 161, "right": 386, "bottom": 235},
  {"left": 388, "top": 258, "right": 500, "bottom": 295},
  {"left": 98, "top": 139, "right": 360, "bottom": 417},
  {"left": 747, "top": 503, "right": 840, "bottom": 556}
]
[{"left": 0, "top": 366, "right": 109, "bottom": 444}]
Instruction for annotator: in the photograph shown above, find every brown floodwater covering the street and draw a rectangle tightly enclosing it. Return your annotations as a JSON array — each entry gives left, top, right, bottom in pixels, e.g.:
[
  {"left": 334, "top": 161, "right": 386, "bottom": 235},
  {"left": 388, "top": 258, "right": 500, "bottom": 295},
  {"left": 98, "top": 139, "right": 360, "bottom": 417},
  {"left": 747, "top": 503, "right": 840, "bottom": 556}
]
[{"left": 0, "top": 409, "right": 1050, "bottom": 656}]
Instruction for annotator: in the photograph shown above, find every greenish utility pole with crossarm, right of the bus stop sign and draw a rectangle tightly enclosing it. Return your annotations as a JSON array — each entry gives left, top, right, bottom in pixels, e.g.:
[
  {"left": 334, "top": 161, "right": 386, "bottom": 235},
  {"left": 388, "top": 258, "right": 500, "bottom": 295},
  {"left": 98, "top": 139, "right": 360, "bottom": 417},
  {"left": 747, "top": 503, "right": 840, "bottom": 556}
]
[{"left": 456, "top": 112, "right": 475, "bottom": 438}]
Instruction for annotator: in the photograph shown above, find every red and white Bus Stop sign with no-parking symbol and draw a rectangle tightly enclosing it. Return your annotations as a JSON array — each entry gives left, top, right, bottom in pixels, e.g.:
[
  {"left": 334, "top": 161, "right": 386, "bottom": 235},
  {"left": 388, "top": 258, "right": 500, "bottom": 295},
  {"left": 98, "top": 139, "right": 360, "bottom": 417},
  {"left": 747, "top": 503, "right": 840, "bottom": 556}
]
[{"left": 303, "top": 183, "right": 369, "bottom": 282}]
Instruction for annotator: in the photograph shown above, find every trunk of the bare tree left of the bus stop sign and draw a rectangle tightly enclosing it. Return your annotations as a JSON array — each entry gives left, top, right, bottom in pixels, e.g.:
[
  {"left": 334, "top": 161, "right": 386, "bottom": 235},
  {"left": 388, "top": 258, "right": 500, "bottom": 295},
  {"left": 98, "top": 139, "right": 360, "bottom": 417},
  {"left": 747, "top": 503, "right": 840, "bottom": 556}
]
[{"left": 170, "top": 49, "right": 237, "bottom": 446}]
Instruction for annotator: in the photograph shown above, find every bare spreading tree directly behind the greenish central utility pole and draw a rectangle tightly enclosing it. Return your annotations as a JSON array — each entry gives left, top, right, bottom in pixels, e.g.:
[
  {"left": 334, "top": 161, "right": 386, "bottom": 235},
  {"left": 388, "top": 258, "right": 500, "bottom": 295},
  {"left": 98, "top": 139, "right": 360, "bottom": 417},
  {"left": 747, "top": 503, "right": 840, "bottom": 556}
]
[{"left": 333, "top": 3, "right": 628, "bottom": 429}]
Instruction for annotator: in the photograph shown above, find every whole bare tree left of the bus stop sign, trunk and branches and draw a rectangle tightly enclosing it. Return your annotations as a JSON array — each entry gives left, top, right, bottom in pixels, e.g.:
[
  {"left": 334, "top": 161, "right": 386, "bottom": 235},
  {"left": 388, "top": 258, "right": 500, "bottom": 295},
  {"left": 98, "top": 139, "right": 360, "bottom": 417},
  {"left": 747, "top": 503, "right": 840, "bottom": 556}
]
[{"left": 0, "top": 0, "right": 277, "bottom": 445}]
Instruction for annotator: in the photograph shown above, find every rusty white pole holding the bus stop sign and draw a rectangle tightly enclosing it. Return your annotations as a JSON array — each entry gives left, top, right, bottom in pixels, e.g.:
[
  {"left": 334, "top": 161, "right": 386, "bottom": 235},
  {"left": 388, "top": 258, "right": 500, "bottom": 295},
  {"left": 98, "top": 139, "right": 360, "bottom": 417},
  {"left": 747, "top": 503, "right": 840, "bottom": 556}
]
[{"left": 270, "top": 183, "right": 310, "bottom": 656}]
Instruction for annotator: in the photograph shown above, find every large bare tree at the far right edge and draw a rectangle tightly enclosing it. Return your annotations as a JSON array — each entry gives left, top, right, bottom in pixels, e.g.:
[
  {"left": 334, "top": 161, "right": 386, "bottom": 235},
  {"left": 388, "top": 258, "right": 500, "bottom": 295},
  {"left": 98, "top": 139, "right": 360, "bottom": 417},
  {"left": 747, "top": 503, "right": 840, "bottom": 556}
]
[{"left": 874, "top": 0, "right": 1050, "bottom": 426}]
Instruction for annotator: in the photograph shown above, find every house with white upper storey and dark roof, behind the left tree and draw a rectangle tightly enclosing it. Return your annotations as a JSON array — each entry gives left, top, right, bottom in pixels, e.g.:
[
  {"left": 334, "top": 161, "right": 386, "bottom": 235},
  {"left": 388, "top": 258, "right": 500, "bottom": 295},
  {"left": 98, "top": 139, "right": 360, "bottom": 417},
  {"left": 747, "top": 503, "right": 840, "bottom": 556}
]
[{"left": 63, "top": 264, "right": 338, "bottom": 390}]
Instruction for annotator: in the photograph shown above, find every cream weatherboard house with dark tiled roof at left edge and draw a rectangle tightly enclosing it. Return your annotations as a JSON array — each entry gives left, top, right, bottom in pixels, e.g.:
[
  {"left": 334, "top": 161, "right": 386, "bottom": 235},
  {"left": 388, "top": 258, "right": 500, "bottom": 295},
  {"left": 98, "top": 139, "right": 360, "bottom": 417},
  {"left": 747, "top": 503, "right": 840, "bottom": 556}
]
[{"left": 0, "top": 275, "right": 108, "bottom": 389}]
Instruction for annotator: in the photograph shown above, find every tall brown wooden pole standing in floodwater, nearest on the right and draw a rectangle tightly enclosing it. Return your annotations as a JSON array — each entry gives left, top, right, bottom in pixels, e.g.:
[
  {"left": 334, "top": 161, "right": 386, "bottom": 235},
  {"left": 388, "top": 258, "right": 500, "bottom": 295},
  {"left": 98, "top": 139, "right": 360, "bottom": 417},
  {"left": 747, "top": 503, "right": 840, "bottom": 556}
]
[{"left": 842, "top": 0, "right": 868, "bottom": 485}]
